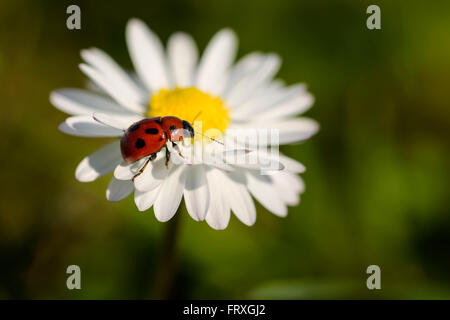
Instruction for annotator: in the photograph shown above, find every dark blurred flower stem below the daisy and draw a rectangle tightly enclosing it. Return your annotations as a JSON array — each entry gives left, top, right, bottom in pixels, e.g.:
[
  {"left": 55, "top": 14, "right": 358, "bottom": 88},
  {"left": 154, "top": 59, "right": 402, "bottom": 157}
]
[{"left": 153, "top": 206, "right": 182, "bottom": 300}]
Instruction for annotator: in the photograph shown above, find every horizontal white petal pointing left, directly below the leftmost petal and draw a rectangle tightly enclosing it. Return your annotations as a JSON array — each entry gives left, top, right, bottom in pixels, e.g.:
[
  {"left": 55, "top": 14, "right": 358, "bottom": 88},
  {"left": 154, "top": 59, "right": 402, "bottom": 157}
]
[{"left": 58, "top": 116, "right": 123, "bottom": 137}]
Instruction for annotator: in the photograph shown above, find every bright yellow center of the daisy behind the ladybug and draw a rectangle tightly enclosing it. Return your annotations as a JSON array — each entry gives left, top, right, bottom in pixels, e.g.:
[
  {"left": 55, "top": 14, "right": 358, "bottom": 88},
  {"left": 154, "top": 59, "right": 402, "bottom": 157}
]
[{"left": 147, "top": 87, "right": 230, "bottom": 137}]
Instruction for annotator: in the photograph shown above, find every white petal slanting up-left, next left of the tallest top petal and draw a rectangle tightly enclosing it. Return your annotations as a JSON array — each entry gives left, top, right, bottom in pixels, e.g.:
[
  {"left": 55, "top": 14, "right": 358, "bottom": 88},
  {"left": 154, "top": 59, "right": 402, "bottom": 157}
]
[{"left": 81, "top": 48, "right": 148, "bottom": 104}]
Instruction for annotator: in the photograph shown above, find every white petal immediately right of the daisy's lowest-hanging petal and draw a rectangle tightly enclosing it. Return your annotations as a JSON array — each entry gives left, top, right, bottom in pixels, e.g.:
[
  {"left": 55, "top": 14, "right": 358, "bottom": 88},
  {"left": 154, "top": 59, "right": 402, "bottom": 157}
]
[{"left": 221, "top": 173, "right": 256, "bottom": 226}]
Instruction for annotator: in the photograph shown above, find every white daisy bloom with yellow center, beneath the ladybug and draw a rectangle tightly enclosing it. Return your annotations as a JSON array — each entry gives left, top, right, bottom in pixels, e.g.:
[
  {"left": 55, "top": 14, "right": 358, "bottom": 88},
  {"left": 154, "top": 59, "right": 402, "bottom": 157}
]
[{"left": 50, "top": 19, "right": 318, "bottom": 229}]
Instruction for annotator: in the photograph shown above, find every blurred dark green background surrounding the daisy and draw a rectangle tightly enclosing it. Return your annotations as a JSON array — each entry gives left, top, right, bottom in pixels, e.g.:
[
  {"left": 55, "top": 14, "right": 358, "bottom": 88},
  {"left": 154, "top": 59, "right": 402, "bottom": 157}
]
[{"left": 0, "top": 0, "right": 450, "bottom": 299}]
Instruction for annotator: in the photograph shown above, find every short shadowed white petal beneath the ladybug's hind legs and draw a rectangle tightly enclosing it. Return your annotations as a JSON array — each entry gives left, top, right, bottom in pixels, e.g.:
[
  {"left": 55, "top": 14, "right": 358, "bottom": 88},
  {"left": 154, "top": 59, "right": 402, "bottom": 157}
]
[{"left": 134, "top": 152, "right": 169, "bottom": 191}]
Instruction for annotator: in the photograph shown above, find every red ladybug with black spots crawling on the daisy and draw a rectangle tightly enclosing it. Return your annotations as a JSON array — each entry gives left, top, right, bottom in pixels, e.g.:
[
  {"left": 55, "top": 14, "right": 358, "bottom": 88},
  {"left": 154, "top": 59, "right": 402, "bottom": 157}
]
[{"left": 120, "top": 117, "right": 194, "bottom": 180}]
